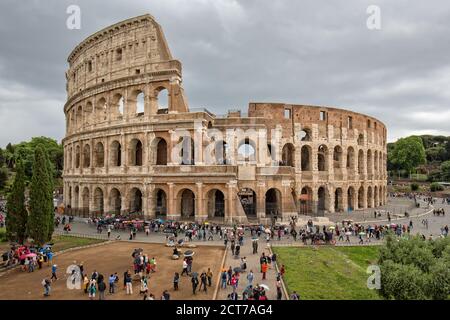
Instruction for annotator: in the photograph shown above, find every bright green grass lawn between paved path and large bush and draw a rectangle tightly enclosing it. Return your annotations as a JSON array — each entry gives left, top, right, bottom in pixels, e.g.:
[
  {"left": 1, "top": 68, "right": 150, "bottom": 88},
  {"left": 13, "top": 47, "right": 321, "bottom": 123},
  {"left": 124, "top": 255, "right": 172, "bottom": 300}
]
[{"left": 274, "top": 246, "right": 380, "bottom": 300}]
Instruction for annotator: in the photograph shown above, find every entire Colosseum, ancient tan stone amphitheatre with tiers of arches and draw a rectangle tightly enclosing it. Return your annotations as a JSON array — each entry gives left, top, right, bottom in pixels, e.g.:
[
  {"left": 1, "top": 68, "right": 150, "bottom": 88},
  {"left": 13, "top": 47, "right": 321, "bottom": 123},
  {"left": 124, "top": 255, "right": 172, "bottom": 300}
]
[{"left": 63, "top": 15, "right": 387, "bottom": 223}]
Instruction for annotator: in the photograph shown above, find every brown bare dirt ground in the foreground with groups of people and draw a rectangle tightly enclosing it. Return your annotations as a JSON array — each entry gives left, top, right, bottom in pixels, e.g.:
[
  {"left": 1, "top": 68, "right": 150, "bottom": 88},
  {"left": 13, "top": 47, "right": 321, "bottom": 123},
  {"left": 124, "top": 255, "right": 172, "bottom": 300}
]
[{"left": 0, "top": 242, "right": 223, "bottom": 300}]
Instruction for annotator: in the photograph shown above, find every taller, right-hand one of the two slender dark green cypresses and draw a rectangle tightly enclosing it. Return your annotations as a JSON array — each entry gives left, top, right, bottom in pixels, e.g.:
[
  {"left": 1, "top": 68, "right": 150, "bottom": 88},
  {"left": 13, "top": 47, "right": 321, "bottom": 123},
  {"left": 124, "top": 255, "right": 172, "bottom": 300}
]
[{"left": 27, "top": 146, "right": 53, "bottom": 245}]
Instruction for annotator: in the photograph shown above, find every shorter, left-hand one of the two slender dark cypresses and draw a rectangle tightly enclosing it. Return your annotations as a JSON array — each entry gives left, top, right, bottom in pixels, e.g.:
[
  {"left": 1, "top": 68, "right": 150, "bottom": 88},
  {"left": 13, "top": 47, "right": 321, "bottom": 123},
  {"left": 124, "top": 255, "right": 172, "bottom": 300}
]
[{"left": 6, "top": 161, "right": 28, "bottom": 243}]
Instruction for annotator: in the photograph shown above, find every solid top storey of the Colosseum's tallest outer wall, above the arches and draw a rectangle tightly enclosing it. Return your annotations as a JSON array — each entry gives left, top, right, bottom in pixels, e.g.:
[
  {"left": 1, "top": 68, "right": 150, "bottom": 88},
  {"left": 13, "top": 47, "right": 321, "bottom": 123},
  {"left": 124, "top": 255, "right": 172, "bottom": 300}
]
[{"left": 66, "top": 15, "right": 181, "bottom": 98}]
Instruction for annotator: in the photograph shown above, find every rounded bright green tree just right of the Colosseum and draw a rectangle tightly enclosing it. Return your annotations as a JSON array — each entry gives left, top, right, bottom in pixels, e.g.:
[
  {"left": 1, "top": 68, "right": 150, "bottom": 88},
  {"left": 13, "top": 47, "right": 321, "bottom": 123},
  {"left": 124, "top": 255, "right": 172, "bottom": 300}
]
[{"left": 388, "top": 136, "right": 426, "bottom": 172}]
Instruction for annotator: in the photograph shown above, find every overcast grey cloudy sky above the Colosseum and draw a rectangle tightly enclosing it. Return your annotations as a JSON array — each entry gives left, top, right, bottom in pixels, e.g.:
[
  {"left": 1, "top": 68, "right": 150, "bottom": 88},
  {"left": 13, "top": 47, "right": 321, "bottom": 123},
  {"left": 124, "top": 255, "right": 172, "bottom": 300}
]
[{"left": 0, "top": 0, "right": 450, "bottom": 147}]
